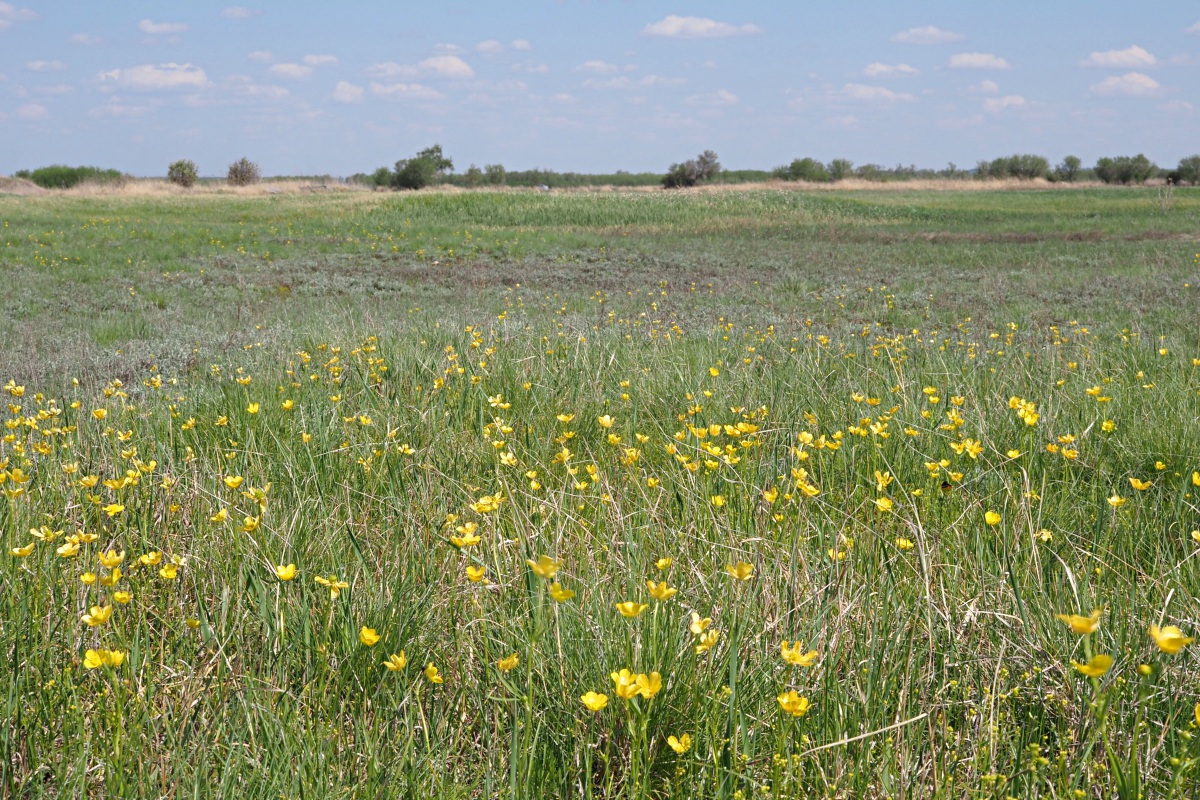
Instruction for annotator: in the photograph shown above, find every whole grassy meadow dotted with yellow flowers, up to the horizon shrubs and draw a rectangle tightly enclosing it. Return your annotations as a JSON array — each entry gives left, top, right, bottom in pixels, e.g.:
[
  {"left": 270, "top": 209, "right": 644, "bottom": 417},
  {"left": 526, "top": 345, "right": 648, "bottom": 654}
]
[{"left": 0, "top": 188, "right": 1200, "bottom": 800}]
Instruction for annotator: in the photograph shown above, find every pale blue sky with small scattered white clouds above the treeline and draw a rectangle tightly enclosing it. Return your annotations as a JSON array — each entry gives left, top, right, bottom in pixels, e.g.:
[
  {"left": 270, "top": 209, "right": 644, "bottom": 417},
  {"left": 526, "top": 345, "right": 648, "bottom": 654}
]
[{"left": 0, "top": 0, "right": 1200, "bottom": 175}]
